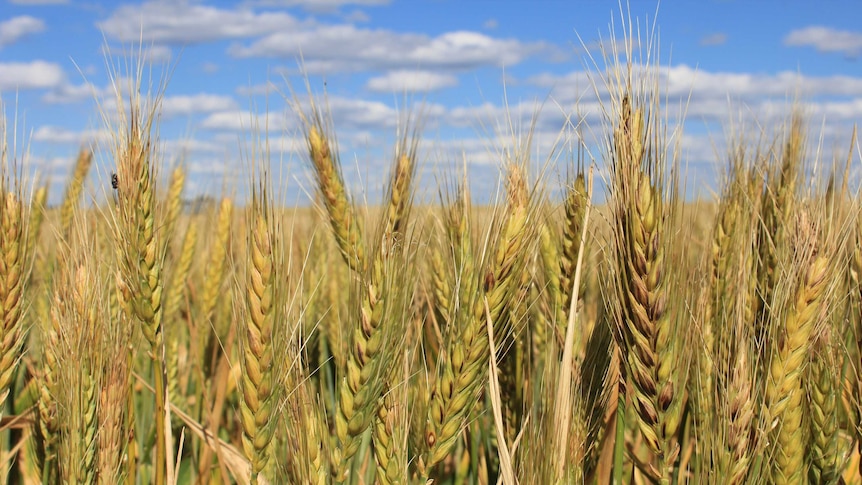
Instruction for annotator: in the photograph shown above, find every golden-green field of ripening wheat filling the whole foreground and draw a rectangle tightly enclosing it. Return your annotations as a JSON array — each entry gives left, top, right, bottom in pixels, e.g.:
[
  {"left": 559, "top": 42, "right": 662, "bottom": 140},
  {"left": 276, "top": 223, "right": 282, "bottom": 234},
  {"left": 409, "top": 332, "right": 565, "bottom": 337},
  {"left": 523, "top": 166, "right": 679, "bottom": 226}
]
[{"left": 0, "top": 15, "right": 862, "bottom": 485}]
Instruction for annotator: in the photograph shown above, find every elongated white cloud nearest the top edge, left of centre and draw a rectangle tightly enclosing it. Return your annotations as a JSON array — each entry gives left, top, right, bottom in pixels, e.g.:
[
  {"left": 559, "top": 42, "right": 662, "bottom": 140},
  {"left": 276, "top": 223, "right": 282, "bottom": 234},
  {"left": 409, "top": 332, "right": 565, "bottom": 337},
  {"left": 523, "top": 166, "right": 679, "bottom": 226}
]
[{"left": 98, "top": 0, "right": 299, "bottom": 44}]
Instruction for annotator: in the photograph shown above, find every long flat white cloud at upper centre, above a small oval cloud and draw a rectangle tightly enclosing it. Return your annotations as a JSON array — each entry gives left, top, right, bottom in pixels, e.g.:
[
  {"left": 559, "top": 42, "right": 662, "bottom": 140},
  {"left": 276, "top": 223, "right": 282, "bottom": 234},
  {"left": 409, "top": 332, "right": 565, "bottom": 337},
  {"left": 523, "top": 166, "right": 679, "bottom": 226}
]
[{"left": 229, "top": 25, "right": 550, "bottom": 72}]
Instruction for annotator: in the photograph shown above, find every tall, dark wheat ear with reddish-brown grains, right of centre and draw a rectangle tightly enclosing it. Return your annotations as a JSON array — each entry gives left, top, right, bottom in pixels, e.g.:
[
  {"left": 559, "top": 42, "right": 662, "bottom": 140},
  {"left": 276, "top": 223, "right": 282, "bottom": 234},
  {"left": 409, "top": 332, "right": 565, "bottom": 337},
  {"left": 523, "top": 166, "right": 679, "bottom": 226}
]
[{"left": 612, "top": 91, "right": 680, "bottom": 481}]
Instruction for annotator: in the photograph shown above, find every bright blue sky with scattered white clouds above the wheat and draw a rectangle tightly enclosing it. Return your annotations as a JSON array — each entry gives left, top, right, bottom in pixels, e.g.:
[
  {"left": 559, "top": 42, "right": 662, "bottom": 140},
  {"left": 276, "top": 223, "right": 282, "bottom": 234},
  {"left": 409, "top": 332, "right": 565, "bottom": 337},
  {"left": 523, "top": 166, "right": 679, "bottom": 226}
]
[{"left": 0, "top": 0, "right": 862, "bottom": 204}]
